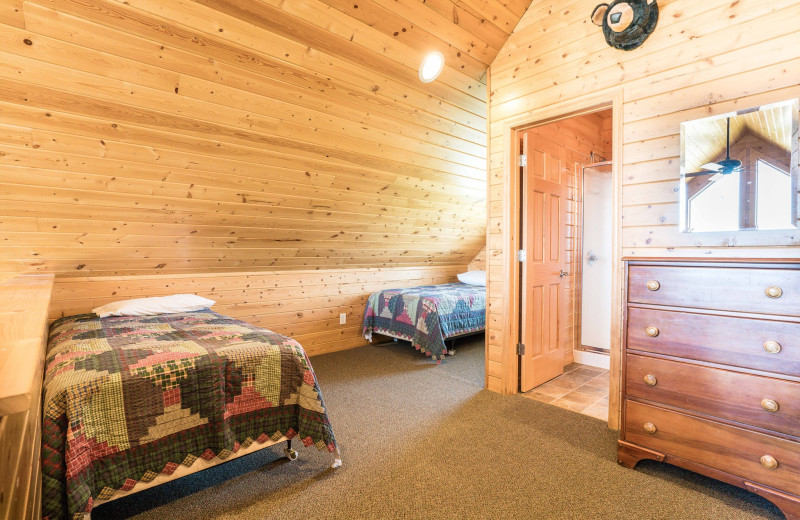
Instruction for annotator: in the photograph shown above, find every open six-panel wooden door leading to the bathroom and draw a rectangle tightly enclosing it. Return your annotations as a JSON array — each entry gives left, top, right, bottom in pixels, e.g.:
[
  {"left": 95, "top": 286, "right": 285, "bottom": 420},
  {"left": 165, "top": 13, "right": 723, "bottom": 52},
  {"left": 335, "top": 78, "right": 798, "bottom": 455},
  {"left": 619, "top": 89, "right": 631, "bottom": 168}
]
[{"left": 520, "top": 132, "right": 569, "bottom": 392}]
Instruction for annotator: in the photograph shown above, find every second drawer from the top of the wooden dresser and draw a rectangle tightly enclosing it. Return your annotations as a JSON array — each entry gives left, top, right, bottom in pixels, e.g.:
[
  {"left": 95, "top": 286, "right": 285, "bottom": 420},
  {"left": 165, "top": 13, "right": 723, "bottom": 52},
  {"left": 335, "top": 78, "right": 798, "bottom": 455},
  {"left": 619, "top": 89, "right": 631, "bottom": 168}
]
[{"left": 627, "top": 307, "right": 800, "bottom": 375}]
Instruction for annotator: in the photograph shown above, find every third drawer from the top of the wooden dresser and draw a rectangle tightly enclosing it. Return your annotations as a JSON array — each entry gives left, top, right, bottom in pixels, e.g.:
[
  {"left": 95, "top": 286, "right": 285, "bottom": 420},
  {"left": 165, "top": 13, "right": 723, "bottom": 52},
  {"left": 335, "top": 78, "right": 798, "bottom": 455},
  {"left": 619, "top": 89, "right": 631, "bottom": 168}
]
[{"left": 625, "top": 354, "right": 800, "bottom": 435}]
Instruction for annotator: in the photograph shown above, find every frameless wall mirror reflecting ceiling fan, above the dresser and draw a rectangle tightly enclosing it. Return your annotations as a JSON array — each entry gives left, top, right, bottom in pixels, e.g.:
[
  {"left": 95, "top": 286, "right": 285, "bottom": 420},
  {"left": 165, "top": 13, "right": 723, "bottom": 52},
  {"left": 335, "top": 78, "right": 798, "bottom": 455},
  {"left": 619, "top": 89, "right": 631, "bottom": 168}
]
[{"left": 680, "top": 99, "right": 800, "bottom": 232}]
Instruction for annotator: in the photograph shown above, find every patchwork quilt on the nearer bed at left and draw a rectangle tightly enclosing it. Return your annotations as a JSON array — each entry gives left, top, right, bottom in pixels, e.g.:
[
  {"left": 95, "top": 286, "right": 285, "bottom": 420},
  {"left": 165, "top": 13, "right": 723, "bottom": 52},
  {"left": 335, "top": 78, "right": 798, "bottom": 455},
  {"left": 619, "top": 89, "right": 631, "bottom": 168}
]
[{"left": 42, "top": 310, "right": 338, "bottom": 520}]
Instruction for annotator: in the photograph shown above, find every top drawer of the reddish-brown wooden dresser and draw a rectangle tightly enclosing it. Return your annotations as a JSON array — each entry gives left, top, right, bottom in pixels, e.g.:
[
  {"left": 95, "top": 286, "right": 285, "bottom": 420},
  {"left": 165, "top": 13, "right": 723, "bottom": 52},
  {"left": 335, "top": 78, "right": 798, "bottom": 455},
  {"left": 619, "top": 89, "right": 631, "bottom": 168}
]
[{"left": 628, "top": 265, "right": 800, "bottom": 316}]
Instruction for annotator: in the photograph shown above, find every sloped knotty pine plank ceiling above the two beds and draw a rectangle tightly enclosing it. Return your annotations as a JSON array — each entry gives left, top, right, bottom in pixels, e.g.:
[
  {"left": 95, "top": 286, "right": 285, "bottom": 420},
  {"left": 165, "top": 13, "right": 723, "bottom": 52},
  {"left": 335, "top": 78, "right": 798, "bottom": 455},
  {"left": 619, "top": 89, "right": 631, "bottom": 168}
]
[{"left": 0, "top": 0, "right": 529, "bottom": 276}]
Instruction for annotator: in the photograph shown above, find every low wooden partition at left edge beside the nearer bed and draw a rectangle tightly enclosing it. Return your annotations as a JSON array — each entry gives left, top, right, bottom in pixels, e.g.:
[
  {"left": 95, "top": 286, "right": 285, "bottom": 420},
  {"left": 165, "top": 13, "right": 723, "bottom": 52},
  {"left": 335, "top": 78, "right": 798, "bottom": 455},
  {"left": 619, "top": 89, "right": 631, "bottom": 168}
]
[{"left": 0, "top": 274, "right": 53, "bottom": 520}]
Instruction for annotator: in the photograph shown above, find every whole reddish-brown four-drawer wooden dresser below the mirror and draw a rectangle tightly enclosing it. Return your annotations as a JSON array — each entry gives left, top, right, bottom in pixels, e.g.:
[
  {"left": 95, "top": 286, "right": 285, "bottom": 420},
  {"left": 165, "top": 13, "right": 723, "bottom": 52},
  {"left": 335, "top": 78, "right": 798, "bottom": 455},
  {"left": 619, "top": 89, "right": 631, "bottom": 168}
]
[{"left": 618, "top": 259, "right": 800, "bottom": 519}]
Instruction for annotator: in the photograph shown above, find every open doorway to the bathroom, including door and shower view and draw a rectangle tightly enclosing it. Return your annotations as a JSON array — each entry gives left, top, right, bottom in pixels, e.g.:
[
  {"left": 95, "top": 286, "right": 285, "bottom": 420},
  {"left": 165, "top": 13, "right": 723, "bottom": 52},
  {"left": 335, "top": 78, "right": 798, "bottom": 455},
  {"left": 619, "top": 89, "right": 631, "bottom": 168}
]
[{"left": 517, "top": 108, "right": 614, "bottom": 419}]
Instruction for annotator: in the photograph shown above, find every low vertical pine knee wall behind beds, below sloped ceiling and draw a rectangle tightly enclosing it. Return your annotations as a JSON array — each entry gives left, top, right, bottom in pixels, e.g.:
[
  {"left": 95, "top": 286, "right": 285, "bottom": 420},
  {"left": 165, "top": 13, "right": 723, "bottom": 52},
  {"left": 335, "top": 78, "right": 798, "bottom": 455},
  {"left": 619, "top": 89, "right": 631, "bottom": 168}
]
[{"left": 50, "top": 264, "right": 466, "bottom": 355}]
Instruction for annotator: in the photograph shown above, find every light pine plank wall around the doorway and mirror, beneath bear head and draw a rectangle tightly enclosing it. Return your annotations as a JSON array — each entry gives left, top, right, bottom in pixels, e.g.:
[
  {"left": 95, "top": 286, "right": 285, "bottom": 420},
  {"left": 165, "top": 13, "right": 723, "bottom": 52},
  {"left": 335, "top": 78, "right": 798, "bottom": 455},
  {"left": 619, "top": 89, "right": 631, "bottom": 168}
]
[{"left": 487, "top": 0, "right": 800, "bottom": 392}]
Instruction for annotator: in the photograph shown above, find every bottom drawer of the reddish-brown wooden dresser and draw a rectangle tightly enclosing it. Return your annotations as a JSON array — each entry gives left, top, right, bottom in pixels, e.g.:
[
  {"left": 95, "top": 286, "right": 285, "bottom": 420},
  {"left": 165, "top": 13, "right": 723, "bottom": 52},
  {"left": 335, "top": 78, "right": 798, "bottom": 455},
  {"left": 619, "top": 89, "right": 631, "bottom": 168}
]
[{"left": 623, "top": 400, "right": 800, "bottom": 490}]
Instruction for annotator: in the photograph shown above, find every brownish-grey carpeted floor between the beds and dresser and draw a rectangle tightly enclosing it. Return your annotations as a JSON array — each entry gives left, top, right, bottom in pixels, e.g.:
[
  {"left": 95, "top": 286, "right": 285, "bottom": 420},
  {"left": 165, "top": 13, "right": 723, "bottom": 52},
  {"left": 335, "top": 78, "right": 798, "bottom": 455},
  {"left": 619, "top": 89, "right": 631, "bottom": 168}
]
[{"left": 92, "top": 337, "right": 782, "bottom": 520}]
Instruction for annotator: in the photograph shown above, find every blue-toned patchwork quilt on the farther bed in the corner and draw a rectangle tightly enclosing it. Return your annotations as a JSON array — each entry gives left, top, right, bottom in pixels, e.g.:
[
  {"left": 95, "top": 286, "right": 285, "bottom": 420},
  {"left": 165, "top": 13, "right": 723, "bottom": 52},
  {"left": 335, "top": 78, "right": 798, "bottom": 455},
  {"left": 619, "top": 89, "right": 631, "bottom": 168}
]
[{"left": 363, "top": 283, "right": 486, "bottom": 363}]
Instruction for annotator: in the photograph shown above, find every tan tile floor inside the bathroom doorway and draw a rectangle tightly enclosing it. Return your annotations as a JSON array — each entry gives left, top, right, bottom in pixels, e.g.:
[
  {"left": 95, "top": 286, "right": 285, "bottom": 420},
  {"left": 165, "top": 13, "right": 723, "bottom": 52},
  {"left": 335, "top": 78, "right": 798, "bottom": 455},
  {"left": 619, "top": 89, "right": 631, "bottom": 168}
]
[{"left": 522, "top": 363, "right": 608, "bottom": 421}]
